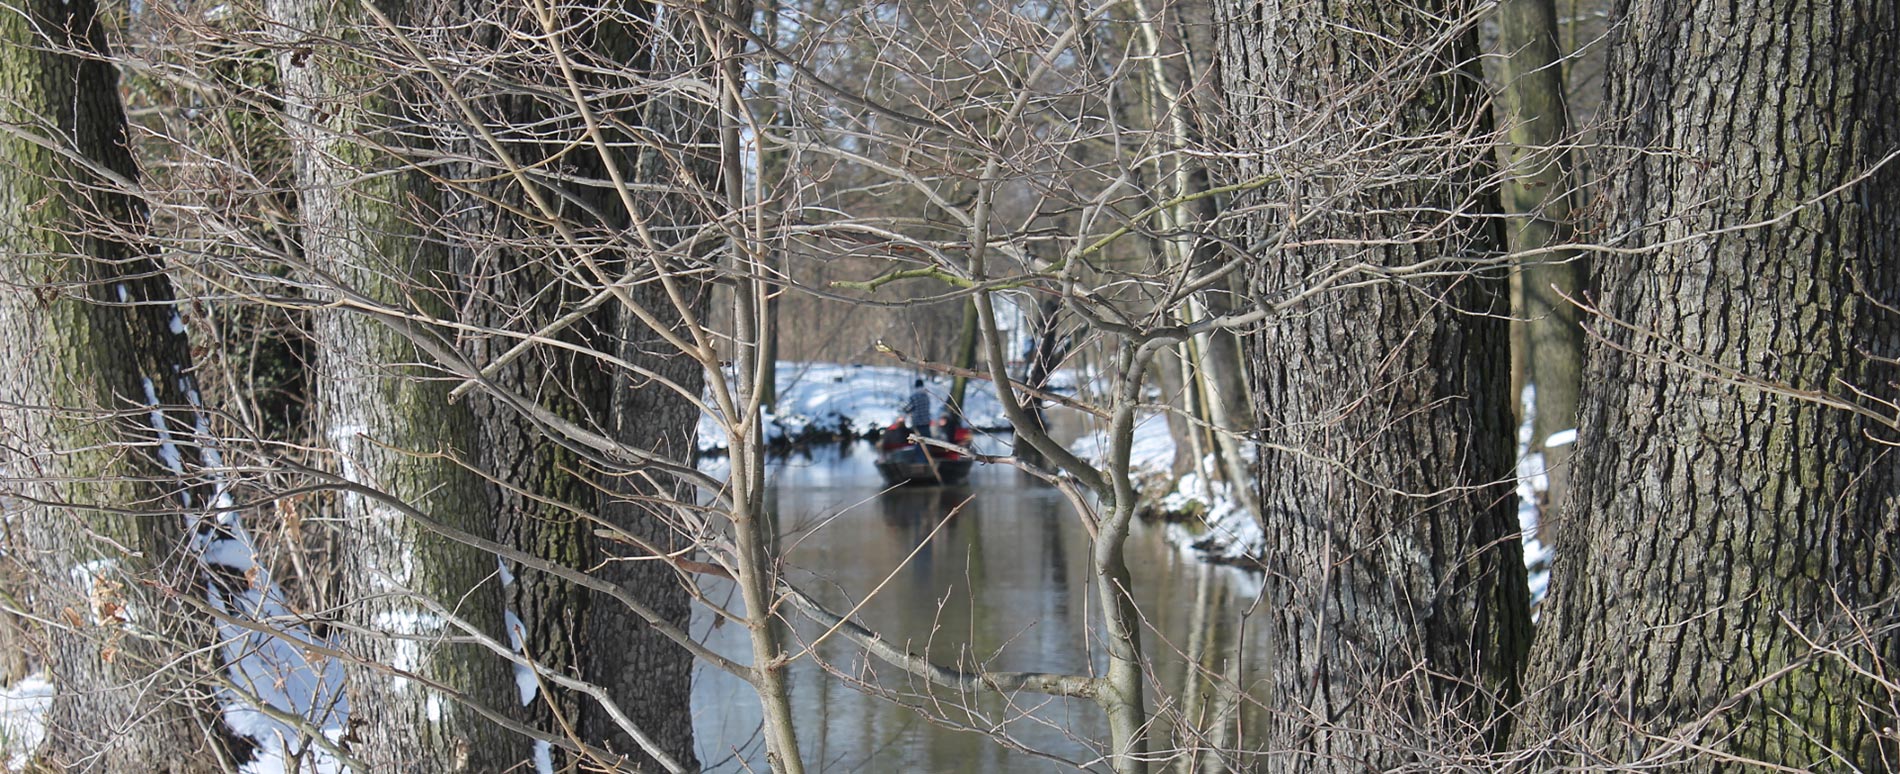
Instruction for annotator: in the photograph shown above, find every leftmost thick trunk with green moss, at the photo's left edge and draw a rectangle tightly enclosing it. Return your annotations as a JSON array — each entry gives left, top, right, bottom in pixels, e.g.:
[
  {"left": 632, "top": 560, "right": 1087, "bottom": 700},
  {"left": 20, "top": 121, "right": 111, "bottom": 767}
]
[{"left": 0, "top": 0, "right": 234, "bottom": 772}]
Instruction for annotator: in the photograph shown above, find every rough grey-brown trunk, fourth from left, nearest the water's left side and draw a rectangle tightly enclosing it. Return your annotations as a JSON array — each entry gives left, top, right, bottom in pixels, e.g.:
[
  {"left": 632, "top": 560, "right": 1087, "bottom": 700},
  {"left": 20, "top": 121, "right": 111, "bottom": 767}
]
[{"left": 581, "top": 4, "right": 724, "bottom": 768}]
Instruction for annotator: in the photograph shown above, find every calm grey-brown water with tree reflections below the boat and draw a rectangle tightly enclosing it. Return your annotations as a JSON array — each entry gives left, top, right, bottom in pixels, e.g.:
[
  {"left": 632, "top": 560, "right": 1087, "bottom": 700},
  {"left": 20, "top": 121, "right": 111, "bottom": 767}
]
[{"left": 694, "top": 445, "right": 1265, "bottom": 772}]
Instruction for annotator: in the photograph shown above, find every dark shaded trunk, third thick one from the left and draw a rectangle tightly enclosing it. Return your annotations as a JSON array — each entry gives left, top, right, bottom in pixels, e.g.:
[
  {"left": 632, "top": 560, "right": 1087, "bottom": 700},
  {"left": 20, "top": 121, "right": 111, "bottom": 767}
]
[{"left": 445, "top": 103, "right": 604, "bottom": 766}]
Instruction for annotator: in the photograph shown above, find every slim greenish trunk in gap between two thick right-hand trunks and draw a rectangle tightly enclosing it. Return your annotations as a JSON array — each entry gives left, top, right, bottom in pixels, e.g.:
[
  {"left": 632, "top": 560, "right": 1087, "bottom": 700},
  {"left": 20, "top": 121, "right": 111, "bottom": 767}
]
[{"left": 1497, "top": 0, "right": 1585, "bottom": 540}]
